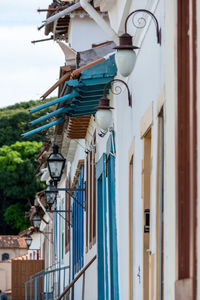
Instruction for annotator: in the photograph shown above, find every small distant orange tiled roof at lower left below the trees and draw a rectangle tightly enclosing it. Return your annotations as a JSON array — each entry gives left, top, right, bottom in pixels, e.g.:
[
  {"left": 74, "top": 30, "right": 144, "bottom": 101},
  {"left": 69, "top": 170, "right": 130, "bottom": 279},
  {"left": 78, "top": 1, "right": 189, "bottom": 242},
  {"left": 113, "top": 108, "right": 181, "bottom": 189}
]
[{"left": 0, "top": 235, "right": 27, "bottom": 249}]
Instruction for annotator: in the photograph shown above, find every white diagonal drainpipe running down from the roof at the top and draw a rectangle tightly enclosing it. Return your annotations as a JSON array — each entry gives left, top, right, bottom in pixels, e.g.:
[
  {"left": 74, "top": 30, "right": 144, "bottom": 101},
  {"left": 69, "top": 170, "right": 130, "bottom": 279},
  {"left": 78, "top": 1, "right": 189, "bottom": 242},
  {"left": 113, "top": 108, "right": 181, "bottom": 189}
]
[{"left": 80, "top": 0, "right": 119, "bottom": 45}]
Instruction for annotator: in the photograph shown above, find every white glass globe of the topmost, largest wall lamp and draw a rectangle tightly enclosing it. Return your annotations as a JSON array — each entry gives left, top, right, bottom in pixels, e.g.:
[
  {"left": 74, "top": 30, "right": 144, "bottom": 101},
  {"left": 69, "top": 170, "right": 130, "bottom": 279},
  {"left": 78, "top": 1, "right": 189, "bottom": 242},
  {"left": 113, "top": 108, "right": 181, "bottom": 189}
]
[{"left": 115, "top": 49, "right": 136, "bottom": 77}]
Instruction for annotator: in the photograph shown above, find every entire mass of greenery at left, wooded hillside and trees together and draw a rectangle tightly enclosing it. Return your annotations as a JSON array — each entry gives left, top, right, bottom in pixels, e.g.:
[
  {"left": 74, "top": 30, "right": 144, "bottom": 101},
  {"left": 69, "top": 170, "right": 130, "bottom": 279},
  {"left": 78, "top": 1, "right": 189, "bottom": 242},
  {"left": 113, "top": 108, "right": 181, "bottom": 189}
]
[{"left": 0, "top": 98, "right": 55, "bottom": 234}]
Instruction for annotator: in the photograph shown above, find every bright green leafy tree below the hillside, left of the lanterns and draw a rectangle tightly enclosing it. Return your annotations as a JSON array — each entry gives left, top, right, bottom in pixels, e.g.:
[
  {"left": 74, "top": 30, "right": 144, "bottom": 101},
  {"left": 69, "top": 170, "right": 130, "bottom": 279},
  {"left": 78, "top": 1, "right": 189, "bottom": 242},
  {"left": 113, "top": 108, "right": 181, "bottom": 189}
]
[{"left": 0, "top": 141, "right": 44, "bottom": 234}]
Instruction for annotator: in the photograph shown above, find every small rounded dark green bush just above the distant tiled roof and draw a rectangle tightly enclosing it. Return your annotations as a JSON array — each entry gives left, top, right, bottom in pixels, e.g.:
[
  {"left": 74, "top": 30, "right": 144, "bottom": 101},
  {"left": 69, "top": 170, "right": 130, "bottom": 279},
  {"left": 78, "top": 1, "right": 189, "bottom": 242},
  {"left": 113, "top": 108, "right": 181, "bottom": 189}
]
[{"left": 4, "top": 202, "right": 30, "bottom": 231}]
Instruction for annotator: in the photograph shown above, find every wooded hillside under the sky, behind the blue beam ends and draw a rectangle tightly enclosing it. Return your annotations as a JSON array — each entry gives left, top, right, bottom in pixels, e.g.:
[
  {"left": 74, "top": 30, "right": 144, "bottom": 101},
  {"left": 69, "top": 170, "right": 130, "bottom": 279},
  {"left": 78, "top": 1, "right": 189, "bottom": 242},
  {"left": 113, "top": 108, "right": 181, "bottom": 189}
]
[{"left": 0, "top": 98, "right": 55, "bottom": 147}]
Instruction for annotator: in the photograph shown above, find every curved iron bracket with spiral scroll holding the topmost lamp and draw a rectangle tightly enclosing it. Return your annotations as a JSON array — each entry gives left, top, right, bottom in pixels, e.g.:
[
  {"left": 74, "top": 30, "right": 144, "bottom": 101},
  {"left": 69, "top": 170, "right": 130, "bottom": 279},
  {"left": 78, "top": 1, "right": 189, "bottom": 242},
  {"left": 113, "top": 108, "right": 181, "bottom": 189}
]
[{"left": 125, "top": 9, "right": 161, "bottom": 45}]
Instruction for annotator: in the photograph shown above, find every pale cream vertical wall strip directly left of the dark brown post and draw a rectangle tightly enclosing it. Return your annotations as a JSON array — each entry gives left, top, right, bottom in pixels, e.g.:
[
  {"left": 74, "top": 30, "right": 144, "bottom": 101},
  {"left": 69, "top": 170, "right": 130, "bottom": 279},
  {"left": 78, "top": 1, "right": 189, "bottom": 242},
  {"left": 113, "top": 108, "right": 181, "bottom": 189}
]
[{"left": 164, "top": 1, "right": 177, "bottom": 300}]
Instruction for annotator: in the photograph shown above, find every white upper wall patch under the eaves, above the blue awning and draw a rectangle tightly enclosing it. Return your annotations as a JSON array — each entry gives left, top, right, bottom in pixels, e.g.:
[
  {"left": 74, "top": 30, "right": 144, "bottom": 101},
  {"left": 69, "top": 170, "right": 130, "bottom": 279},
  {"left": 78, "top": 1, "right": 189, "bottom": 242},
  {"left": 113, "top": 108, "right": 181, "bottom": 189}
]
[{"left": 69, "top": 16, "right": 109, "bottom": 51}]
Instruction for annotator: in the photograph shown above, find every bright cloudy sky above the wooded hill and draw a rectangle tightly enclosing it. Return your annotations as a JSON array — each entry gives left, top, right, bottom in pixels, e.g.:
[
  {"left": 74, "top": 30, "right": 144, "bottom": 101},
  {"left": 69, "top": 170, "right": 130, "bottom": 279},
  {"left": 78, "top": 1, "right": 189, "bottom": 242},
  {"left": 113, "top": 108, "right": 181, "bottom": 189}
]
[{"left": 0, "top": 0, "right": 64, "bottom": 107}]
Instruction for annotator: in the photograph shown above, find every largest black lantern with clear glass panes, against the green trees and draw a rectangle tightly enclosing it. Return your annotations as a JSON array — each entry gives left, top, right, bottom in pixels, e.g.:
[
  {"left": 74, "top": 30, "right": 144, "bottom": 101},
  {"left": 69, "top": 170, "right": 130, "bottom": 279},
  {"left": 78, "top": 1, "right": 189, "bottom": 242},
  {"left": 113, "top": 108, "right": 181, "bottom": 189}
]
[{"left": 47, "top": 145, "right": 66, "bottom": 182}]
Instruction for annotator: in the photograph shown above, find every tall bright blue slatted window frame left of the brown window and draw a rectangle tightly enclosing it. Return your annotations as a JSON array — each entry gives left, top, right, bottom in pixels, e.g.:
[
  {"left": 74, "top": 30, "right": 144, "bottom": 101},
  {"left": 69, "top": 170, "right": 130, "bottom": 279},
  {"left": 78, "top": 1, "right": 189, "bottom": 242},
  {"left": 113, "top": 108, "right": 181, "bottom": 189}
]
[{"left": 72, "top": 166, "right": 85, "bottom": 278}]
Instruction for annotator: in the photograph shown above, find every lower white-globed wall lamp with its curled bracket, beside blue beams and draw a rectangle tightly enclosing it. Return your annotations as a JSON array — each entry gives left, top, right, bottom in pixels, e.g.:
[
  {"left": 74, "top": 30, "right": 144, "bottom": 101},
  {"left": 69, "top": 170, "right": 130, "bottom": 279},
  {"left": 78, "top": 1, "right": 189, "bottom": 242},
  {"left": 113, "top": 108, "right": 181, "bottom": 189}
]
[{"left": 95, "top": 79, "right": 132, "bottom": 131}]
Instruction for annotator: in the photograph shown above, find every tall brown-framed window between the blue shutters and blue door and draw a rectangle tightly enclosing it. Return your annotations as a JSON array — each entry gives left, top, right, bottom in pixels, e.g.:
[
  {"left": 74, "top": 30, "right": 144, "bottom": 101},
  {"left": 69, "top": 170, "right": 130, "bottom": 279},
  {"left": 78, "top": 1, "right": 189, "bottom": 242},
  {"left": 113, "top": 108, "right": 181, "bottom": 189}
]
[{"left": 86, "top": 135, "right": 96, "bottom": 252}]
